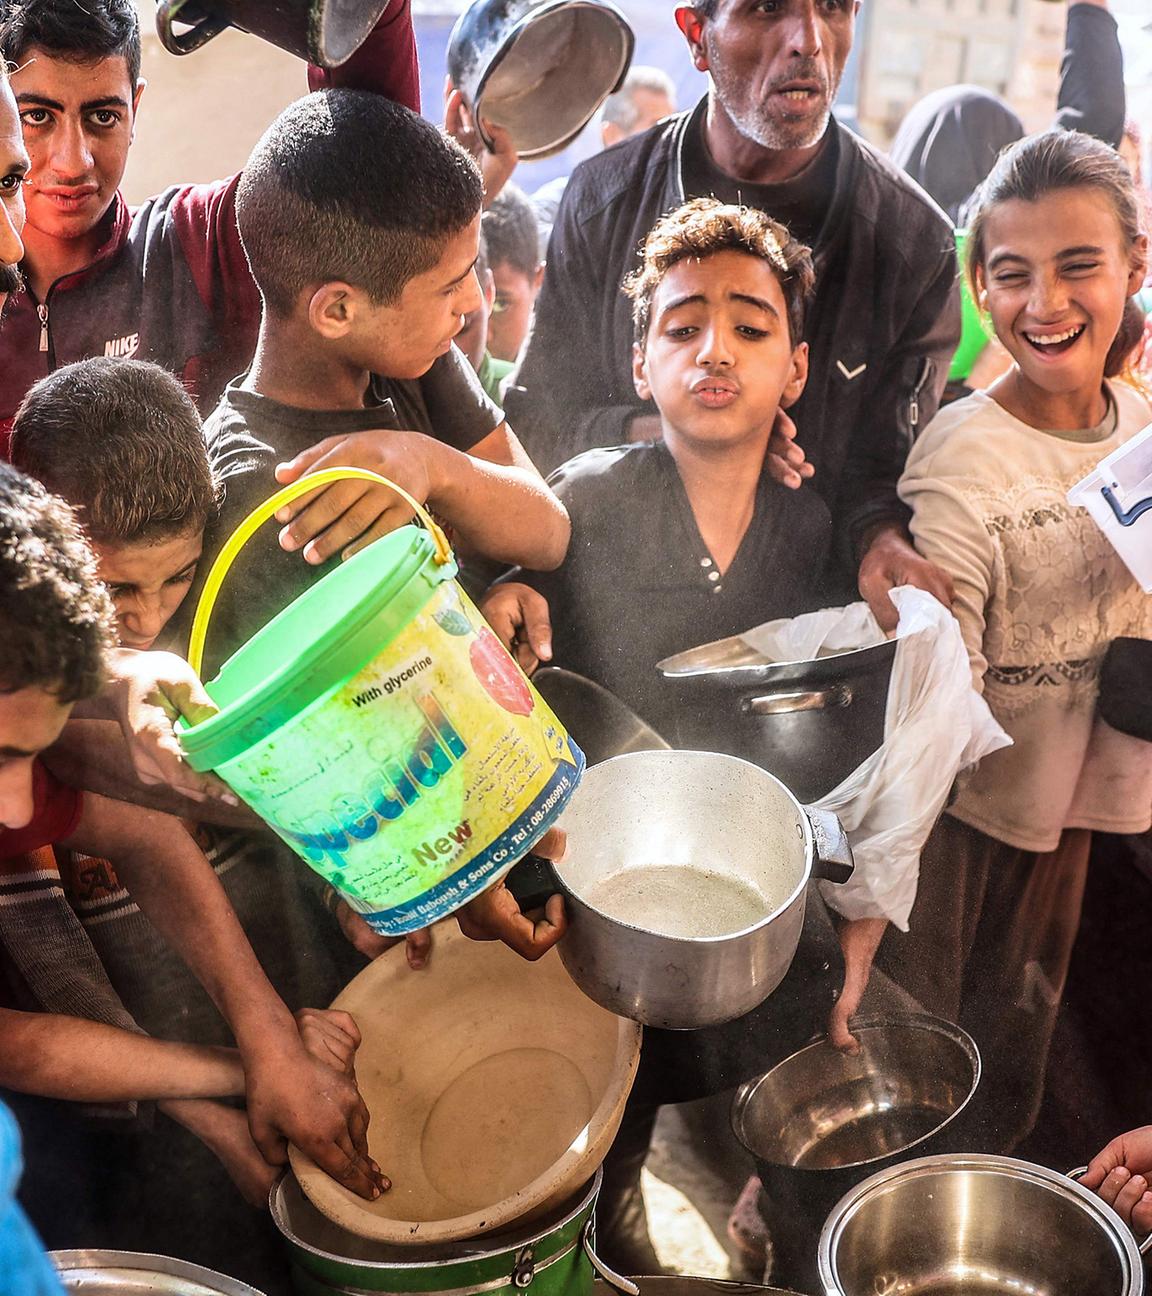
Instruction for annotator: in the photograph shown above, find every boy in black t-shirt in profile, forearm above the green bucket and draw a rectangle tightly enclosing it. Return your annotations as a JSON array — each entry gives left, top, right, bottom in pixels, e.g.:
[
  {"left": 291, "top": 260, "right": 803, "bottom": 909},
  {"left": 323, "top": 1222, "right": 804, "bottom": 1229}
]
[{"left": 190, "top": 91, "right": 568, "bottom": 671}]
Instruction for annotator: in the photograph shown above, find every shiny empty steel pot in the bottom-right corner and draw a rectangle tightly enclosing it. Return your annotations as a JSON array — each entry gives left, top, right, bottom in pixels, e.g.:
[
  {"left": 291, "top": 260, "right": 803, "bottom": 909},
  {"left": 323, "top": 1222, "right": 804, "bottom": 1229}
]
[{"left": 819, "top": 1156, "right": 1152, "bottom": 1296}]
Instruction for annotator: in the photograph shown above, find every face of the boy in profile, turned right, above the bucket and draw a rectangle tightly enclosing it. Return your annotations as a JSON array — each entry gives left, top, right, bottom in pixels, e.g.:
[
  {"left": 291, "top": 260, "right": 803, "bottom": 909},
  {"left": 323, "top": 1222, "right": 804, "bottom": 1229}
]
[{"left": 345, "top": 214, "right": 481, "bottom": 378}]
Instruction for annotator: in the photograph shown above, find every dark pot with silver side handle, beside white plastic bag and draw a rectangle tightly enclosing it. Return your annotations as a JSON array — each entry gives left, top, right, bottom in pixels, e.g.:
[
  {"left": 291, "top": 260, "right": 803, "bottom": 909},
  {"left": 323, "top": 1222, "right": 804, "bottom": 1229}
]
[{"left": 657, "top": 636, "right": 897, "bottom": 801}]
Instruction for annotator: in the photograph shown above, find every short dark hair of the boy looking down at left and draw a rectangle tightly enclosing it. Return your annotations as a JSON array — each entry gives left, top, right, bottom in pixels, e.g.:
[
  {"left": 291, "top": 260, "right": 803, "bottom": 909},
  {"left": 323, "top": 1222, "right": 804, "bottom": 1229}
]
[{"left": 12, "top": 356, "right": 218, "bottom": 544}]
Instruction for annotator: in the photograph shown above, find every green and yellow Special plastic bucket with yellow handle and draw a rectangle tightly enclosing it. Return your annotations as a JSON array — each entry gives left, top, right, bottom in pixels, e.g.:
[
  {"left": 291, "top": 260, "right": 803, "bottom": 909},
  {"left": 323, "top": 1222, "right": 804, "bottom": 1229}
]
[{"left": 179, "top": 469, "right": 584, "bottom": 936}]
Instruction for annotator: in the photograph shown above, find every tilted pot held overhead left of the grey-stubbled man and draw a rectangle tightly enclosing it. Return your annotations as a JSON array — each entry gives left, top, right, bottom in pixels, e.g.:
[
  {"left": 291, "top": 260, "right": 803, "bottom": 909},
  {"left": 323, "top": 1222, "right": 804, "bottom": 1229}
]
[{"left": 448, "top": 0, "right": 635, "bottom": 158}]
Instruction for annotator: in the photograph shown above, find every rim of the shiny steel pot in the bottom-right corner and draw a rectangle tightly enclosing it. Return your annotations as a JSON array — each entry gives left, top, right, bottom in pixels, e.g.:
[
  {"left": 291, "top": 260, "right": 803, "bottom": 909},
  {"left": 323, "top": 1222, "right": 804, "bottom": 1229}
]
[{"left": 816, "top": 1152, "right": 1143, "bottom": 1296}]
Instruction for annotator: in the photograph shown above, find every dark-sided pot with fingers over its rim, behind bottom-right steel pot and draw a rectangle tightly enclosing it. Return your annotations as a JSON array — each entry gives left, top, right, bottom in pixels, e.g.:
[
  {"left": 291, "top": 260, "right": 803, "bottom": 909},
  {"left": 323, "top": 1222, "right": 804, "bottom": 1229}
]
[{"left": 732, "top": 1012, "right": 980, "bottom": 1296}]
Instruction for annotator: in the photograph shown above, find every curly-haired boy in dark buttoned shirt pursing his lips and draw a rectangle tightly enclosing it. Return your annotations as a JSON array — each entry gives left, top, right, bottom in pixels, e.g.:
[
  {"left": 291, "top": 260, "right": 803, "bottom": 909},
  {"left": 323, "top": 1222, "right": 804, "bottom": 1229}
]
[{"left": 485, "top": 198, "right": 831, "bottom": 739}]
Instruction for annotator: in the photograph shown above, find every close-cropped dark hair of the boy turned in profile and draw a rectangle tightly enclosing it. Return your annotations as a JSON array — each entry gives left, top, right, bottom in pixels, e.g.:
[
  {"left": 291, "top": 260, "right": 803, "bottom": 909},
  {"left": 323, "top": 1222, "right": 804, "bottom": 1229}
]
[{"left": 236, "top": 89, "right": 483, "bottom": 315}]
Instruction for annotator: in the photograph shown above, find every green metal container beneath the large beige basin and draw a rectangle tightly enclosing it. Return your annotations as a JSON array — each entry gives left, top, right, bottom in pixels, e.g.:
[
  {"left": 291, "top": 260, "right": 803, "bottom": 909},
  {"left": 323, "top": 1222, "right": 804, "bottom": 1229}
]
[{"left": 268, "top": 1170, "right": 636, "bottom": 1296}]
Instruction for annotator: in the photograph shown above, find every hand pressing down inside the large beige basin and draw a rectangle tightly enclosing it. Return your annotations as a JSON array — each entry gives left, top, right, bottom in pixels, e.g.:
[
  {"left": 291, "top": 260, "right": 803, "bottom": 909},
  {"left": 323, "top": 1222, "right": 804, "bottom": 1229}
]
[{"left": 245, "top": 1013, "right": 391, "bottom": 1201}]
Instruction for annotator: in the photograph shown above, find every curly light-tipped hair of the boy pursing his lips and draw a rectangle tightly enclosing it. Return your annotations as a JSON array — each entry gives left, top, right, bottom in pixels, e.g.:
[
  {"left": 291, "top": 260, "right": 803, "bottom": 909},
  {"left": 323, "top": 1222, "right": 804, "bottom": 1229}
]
[{"left": 623, "top": 198, "right": 816, "bottom": 346}]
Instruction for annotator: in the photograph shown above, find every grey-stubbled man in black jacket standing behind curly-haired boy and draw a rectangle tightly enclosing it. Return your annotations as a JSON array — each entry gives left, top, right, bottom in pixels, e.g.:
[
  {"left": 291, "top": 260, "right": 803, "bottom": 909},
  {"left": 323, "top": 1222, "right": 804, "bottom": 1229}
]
[{"left": 505, "top": 0, "right": 960, "bottom": 626}]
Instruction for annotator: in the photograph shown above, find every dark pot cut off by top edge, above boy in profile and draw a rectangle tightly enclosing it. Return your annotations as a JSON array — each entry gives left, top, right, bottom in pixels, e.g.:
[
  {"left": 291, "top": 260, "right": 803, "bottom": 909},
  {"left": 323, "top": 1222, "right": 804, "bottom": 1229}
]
[{"left": 156, "top": 0, "right": 387, "bottom": 67}]
